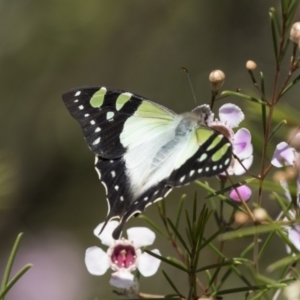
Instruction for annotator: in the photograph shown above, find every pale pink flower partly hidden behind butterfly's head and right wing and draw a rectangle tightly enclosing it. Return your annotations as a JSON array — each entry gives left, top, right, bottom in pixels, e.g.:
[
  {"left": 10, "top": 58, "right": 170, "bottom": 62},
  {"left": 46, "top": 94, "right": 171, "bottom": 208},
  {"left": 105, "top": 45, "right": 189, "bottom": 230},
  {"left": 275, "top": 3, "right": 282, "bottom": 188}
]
[{"left": 207, "top": 103, "right": 253, "bottom": 175}]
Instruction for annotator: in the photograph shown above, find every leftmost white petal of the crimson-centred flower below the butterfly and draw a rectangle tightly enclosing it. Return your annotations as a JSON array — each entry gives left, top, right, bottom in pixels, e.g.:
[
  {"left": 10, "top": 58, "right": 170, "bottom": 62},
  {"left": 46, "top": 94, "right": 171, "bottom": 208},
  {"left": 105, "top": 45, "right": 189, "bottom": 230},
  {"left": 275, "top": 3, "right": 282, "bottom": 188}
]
[{"left": 84, "top": 246, "right": 110, "bottom": 276}]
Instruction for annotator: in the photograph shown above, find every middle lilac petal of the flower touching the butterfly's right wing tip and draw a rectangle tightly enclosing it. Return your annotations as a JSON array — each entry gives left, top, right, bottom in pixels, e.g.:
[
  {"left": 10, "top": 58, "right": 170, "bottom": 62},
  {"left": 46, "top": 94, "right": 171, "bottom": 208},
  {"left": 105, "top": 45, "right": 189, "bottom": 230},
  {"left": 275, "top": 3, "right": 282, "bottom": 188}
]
[{"left": 233, "top": 128, "right": 253, "bottom": 159}]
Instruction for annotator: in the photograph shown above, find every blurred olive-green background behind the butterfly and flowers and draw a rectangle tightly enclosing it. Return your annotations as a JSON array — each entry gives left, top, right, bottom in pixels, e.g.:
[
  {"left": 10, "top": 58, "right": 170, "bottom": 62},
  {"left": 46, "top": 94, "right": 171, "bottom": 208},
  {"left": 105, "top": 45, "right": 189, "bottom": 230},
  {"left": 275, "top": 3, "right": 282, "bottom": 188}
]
[{"left": 0, "top": 0, "right": 300, "bottom": 300}]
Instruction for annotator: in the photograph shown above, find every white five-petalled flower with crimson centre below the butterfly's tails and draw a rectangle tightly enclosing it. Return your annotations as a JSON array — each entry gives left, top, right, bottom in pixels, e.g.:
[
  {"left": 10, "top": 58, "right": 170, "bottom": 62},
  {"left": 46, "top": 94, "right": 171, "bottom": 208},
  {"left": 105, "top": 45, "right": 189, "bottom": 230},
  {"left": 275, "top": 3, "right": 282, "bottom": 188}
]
[{"left": 85, "top": 221, "right": 160, "bottom": 289}]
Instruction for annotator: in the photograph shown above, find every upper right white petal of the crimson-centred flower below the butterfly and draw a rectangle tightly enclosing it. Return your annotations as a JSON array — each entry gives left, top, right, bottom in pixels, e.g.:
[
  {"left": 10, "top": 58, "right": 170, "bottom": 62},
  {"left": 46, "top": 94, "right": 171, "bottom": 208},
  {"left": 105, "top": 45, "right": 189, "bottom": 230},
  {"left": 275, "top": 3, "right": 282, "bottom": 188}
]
[{"left": 127, "top": 227, "right": 155, "bottom": 248}]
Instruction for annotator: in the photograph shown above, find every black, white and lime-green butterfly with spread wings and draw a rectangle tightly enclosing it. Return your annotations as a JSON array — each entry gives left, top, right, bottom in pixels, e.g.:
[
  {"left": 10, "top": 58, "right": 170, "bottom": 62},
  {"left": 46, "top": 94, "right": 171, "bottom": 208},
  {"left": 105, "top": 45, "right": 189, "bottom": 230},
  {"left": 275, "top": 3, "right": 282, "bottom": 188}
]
[{"left": 62, "top": 86, "right": 232, "bottom": 239}]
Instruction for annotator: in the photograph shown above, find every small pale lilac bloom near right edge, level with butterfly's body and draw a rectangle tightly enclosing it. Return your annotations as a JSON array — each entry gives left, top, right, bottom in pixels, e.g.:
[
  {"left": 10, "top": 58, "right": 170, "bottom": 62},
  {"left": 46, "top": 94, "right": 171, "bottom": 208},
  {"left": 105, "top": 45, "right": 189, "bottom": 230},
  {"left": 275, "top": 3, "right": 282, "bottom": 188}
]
[{"left": 271, "top": 142, "right": 295, "bottom": 168}]
